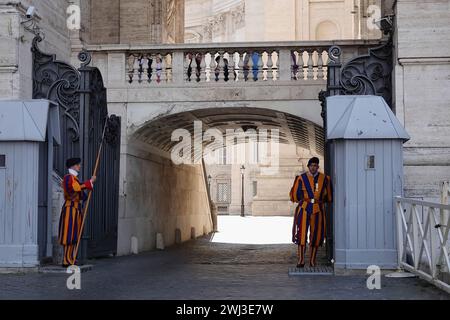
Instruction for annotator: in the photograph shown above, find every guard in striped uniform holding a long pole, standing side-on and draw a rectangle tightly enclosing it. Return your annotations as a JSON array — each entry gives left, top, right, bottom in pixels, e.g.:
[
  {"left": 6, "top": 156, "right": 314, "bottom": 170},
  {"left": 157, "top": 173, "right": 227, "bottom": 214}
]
[{"left": 58, "top": 158, "right": 96, "bottom": 267}]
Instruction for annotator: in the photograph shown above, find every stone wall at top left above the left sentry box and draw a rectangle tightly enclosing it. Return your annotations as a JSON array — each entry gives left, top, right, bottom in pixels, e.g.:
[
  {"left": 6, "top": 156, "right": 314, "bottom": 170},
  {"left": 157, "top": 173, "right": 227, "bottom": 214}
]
[{"left": 0, "top": 0, "right": 71, "bottom": 99}]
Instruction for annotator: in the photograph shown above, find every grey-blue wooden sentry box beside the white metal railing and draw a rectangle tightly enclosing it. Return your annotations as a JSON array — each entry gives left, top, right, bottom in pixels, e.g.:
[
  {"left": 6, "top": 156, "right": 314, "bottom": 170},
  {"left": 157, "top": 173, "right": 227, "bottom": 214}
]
[{"left": 326, "top": 96, "right": 410, "bottom": 272}]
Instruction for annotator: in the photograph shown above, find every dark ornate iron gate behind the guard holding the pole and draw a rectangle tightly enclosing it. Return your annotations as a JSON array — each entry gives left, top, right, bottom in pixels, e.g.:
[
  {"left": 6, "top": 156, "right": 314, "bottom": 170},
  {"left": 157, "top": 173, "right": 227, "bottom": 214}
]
[{"left": 32, "top": 36, "right": 120, "bottom": 258}]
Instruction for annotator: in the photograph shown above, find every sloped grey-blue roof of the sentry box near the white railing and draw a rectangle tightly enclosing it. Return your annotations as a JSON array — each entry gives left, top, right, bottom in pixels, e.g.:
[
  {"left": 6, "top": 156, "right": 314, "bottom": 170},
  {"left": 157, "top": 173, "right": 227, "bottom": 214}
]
[{"left": 327, "top": 96, "right": 410, "bottom": 141}]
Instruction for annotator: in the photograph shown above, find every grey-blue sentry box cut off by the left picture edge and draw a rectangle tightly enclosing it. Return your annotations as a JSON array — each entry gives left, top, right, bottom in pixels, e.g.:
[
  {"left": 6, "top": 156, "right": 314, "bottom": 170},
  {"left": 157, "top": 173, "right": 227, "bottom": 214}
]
[{"left": 0, "top": 99, "right": 60, "bottom": 268}]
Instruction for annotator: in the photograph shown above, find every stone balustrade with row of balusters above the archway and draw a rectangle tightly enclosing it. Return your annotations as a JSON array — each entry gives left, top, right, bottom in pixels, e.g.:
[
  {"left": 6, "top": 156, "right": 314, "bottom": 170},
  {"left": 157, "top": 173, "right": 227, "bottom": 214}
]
[{"left": 83, "top": 40, "right": 377, "bottom": 86}]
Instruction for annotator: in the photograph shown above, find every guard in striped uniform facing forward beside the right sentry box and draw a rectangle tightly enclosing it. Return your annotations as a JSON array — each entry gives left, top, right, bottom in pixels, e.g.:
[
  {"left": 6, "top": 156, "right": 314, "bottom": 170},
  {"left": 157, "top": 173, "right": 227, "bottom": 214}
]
[{"left": 289, "top": 157, "right": 333, "bottom": 268}]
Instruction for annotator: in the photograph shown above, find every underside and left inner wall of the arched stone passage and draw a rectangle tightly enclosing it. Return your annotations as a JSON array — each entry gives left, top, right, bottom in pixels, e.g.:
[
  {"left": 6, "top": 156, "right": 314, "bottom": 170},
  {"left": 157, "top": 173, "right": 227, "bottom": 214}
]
[{"left": 119, "top": 107, "right": 323, "bottom": 254}]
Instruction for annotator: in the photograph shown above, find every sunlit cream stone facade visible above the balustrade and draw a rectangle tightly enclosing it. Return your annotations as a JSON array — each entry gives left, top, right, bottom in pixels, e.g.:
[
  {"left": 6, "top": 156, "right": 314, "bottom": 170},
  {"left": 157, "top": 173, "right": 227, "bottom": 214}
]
[{"left": 185, "top": 0, "right": 382, "bottom": 43}]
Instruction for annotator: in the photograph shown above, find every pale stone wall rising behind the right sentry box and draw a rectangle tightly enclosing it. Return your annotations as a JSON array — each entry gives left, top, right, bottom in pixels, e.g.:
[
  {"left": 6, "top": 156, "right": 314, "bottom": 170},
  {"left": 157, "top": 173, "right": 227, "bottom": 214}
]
[{"left": 395, "top": 0, "right": 450, "bottom": 200}]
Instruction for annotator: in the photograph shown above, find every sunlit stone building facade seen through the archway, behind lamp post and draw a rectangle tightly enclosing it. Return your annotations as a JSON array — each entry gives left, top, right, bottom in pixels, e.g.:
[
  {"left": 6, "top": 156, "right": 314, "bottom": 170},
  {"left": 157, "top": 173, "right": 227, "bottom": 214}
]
[{"left": 207, "top": 144, "right": 323, "bottom": 216}]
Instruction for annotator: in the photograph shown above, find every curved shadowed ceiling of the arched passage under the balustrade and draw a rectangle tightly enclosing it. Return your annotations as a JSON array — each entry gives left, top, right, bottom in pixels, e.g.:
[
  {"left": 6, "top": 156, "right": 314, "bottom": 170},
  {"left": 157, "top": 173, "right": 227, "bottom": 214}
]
[{"left": 133, "top": 108, "right": 324, "bottom": 155}]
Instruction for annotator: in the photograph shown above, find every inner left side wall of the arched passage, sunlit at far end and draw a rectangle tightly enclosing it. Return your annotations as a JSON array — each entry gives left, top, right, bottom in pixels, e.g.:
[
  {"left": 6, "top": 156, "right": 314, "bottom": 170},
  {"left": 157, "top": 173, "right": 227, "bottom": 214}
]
[{"left": 118, "top": 138, "right": 212, "bottom": 255}]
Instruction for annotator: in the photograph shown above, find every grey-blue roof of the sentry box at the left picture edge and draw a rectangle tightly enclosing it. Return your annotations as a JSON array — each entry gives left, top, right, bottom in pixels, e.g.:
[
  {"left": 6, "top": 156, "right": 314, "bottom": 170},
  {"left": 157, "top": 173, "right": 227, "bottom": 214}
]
[{"left": 0, "top": 99, "right": 60, "bottom": 144}]
